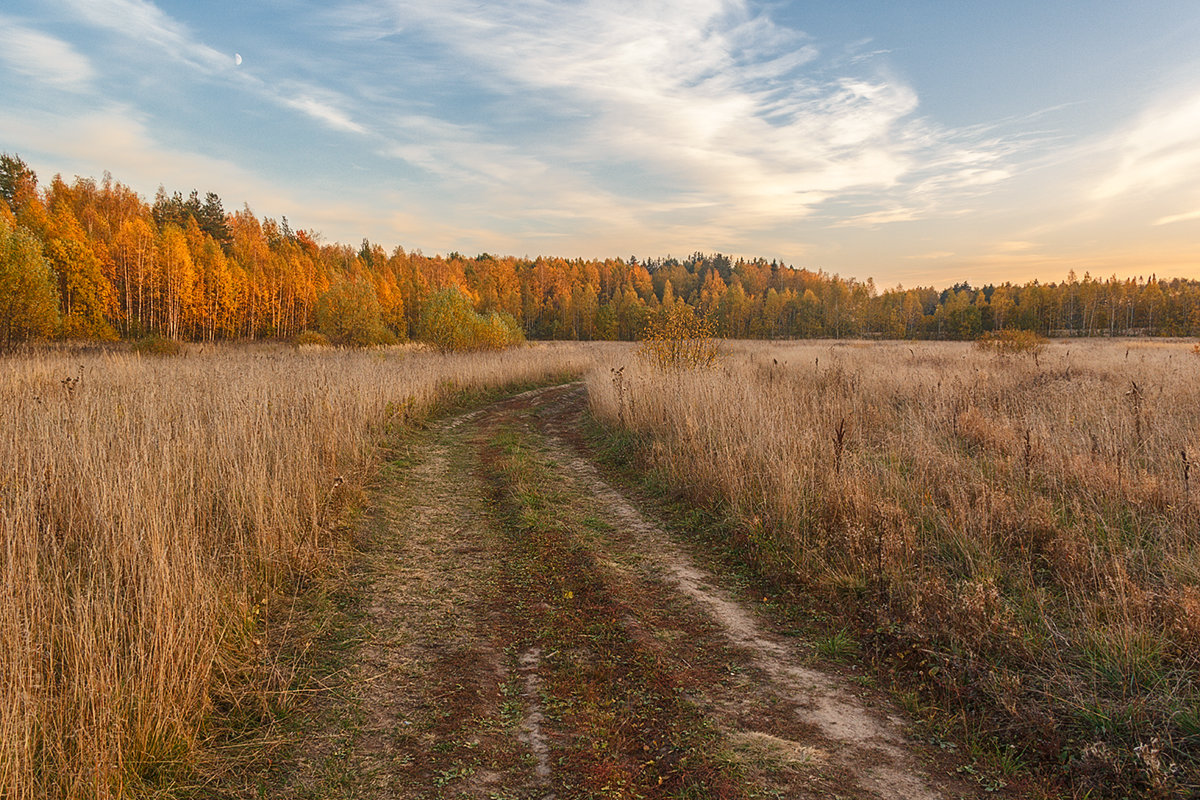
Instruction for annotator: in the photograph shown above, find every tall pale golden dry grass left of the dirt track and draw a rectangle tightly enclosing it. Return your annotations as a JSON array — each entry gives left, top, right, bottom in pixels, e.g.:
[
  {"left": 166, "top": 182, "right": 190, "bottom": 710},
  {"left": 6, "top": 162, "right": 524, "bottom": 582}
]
[{"left": 0, "top": 345, "right": 600, "bottom": 799}]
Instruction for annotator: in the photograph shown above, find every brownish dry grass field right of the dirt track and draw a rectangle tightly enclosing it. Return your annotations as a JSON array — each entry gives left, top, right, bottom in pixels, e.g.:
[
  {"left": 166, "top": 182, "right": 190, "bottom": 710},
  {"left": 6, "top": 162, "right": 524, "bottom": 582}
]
[{"left": 588, "top": 341, "right": 1200, "bottom": 795}]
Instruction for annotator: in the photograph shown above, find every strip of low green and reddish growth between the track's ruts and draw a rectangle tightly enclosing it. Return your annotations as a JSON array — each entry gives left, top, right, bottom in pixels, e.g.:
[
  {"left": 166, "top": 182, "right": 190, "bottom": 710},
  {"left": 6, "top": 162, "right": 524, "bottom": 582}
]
[{"left": 482, "top": 428, "right": 744, "bottom": 799}]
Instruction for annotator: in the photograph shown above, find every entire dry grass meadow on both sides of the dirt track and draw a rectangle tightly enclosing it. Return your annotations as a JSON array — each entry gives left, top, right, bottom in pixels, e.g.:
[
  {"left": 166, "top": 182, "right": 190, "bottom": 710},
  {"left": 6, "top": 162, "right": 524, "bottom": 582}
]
[{"left": 0, "top": 339, "right": 1200, "bottom": 798}]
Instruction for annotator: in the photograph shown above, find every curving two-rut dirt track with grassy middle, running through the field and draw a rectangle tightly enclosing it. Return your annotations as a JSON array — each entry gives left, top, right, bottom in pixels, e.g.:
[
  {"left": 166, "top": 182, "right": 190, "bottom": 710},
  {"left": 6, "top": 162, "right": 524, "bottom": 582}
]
[{"left": 259, "top": 385, "right": 978, "bottom": 799}]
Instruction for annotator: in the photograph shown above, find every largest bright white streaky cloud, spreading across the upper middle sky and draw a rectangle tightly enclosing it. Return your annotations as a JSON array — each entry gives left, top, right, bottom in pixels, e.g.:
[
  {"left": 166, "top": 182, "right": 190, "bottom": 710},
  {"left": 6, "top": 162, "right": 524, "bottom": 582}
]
[{"left": 331, "top": 0, "right": 1009, "bottom": 227}]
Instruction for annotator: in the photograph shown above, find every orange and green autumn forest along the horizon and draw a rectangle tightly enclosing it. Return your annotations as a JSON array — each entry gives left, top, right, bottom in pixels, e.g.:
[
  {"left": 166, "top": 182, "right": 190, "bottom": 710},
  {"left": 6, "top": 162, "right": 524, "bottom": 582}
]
[{"left": 0, "top": 155, "right": 1200, "bottom": 344}]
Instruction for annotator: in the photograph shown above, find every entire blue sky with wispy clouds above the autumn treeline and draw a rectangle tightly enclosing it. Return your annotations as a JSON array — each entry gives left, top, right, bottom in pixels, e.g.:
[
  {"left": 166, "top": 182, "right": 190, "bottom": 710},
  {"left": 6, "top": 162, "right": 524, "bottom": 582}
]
[{"left": 0, "top": 0, "right": 1200, "bottom": 288}]
